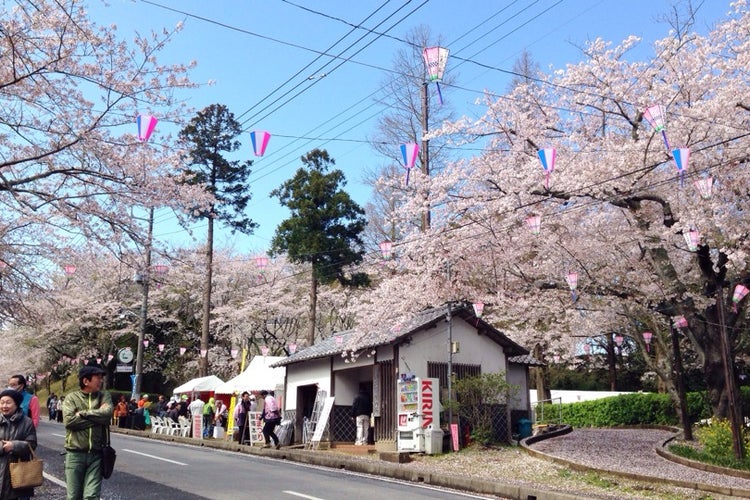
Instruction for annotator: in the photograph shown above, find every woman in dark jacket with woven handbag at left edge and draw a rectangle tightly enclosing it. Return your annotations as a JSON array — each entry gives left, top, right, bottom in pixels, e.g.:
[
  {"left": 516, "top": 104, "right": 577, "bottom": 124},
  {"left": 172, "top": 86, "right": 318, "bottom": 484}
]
[{"left": 0, "top": 389, "right": 36, "bottom": 499}]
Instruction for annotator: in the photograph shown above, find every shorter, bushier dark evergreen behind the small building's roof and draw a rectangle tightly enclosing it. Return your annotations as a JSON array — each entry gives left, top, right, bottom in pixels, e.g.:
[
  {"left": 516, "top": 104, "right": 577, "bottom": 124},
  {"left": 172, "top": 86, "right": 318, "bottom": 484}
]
[{"left": 271, "top": 149, "right": 367, "bottom": 345}]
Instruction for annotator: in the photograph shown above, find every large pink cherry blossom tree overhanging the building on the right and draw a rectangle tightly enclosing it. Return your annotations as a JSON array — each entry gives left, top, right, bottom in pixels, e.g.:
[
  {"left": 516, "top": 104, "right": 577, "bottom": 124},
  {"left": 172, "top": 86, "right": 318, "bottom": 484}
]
[{"left": 355, "top": 2, "right": 750, "bottom": 428}]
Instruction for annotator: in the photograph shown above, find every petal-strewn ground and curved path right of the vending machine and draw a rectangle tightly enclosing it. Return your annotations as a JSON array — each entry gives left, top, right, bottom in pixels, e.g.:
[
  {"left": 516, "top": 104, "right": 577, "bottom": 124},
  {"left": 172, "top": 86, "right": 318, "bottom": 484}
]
[{"left": 330, "top": 429, "right": 750, "bottom": 500}]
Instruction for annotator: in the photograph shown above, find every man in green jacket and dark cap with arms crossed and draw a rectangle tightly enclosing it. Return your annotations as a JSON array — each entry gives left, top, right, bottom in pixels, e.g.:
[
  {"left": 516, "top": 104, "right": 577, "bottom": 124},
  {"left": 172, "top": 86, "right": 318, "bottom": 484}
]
[{"left": 63, "top": 364, "right": 112, "bottom": 500}]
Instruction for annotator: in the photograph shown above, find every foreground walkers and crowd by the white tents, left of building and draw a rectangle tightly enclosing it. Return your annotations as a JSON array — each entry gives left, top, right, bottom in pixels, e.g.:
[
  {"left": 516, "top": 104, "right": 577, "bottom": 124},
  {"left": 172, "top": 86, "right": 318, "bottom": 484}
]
[{"left": 0, "top": 364, "right": 290, "bottom": 500}]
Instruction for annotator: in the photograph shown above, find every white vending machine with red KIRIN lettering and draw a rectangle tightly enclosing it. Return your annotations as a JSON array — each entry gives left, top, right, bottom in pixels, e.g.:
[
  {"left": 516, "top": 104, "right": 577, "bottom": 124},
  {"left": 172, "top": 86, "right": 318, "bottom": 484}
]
[{"left": 396, "top": 374, "right": 443, "bottom": 453}]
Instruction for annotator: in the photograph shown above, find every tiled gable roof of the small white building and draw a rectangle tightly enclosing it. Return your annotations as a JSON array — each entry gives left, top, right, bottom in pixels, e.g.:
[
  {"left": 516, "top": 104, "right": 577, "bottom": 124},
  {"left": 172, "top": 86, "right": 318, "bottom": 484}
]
[{"left": 271, "top": 304, "right": 528, "bottom": 367}]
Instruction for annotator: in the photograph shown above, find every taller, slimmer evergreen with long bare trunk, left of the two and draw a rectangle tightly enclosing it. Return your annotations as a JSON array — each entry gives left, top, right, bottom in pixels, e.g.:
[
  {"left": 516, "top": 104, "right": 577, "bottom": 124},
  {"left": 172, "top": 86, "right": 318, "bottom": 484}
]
[{"left": 180, "top": 104, "right": 257, "bottom": 376}]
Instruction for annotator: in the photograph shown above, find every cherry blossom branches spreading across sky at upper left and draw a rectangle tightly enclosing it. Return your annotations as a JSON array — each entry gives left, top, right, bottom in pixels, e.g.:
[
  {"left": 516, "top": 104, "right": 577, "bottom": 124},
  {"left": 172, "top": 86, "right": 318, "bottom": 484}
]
[{"left": 0, "top": 0, "right": 212, "bottom": 317}]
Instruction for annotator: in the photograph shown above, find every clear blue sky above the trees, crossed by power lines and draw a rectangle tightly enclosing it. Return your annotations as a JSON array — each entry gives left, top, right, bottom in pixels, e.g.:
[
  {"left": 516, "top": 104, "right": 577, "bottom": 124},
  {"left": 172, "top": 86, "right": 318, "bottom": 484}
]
[{"left": 85, "top": 0, "right": 729, "bottom": 254}]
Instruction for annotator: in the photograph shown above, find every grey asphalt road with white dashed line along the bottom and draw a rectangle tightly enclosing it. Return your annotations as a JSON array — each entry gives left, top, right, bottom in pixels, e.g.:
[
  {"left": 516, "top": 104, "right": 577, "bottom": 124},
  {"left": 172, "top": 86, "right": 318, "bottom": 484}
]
[{"left": 36, "top": 421, "right": 496, "bottom": 500}]
